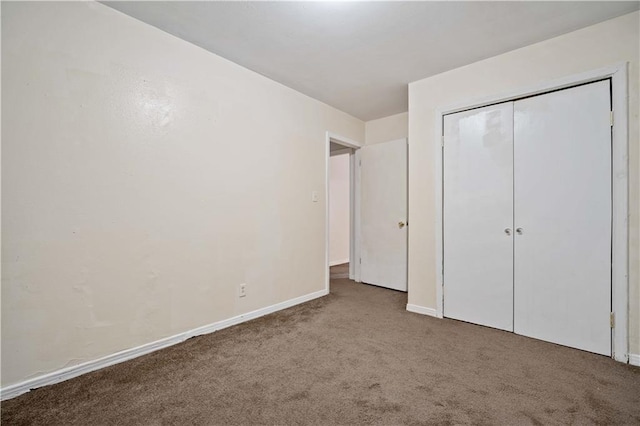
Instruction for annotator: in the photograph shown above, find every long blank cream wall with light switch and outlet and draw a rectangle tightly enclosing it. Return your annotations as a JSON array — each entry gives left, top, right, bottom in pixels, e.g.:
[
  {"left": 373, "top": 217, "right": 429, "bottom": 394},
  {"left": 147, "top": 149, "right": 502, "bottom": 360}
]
[{"left": 2, "top": 2, "right": 364, "bottom": 386}]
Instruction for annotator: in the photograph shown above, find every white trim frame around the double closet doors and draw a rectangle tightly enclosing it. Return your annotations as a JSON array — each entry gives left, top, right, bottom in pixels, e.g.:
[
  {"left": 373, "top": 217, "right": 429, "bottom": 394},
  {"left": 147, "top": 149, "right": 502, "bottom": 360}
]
[{"left": 434, "top": 62, "right": 629, "bottom": 363}]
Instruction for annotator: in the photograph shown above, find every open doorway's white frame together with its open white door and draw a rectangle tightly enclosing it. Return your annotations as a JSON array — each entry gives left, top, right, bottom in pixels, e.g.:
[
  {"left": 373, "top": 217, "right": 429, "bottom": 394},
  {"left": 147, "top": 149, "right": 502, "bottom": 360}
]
[{"left": 325, "top": 133, "right": 408, "bottom": 292}]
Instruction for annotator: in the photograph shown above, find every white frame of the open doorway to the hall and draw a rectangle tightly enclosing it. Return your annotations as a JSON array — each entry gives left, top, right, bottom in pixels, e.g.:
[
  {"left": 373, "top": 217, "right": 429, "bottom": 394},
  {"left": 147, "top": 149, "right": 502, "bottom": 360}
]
[{"left": 324, "top": 131, "right": 363, "bottom": 294}]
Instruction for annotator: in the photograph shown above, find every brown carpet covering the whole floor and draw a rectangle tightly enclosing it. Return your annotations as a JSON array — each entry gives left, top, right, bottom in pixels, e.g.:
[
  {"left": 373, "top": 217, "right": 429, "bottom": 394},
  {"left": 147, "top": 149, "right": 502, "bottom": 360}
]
[{"left": 1, "top": 279, "right": 640, "bottom": 425}]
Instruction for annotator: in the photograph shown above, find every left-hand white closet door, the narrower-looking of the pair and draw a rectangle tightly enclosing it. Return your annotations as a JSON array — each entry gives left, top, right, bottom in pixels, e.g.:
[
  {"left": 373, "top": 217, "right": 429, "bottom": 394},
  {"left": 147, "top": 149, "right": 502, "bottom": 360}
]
[{"left": 443, "top": 102, "right": 513, "bottom": 331}]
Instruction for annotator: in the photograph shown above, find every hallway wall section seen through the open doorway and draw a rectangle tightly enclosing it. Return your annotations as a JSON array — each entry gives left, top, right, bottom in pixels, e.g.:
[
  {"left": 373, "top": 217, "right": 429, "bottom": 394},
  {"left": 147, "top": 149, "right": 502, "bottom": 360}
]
[{"left": 329, "top": 153, "right": 351, "bottom": 265}]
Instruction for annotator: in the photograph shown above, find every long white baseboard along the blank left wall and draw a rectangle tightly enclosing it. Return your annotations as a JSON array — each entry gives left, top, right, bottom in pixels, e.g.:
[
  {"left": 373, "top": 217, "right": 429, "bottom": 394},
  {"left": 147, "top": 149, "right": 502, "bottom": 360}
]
[{"left": 0, "top": 289, "right": 328, "bottom": 401}]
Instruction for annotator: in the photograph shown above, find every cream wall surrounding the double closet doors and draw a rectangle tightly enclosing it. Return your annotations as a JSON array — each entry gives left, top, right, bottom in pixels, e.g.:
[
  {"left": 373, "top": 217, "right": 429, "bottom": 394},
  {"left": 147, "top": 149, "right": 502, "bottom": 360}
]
[{"left": 409, "top": 12, "right": 640, "bottom": 354}]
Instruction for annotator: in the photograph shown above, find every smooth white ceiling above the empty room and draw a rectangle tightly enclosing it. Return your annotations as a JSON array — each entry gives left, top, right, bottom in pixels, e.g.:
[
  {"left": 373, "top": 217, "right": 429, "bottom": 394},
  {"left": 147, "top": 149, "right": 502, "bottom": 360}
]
[{"left": 104, "top": 1, "right": 640, "bottom": 120}]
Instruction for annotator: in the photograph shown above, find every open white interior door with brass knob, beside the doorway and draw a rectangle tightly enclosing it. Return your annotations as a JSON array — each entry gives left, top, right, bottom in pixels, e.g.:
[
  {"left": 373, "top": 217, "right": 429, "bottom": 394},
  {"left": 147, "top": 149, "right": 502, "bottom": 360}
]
[{"left": 358, "top": 139, "right": 407, "bottom": 291}]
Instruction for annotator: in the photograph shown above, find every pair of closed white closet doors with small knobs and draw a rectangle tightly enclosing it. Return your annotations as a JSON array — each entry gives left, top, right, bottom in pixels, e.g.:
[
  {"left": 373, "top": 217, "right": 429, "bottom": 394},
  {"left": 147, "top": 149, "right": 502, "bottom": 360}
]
[{"left": 443, "top": 80, "right": 612, "bottom": 355}]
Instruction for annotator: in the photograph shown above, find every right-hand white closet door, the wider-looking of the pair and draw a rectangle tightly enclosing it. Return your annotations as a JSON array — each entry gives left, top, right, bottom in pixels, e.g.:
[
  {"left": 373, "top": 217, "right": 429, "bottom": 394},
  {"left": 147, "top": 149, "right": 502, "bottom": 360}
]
[{"left": 514, "top": 80, "right": 611, "bottom": 355}]
